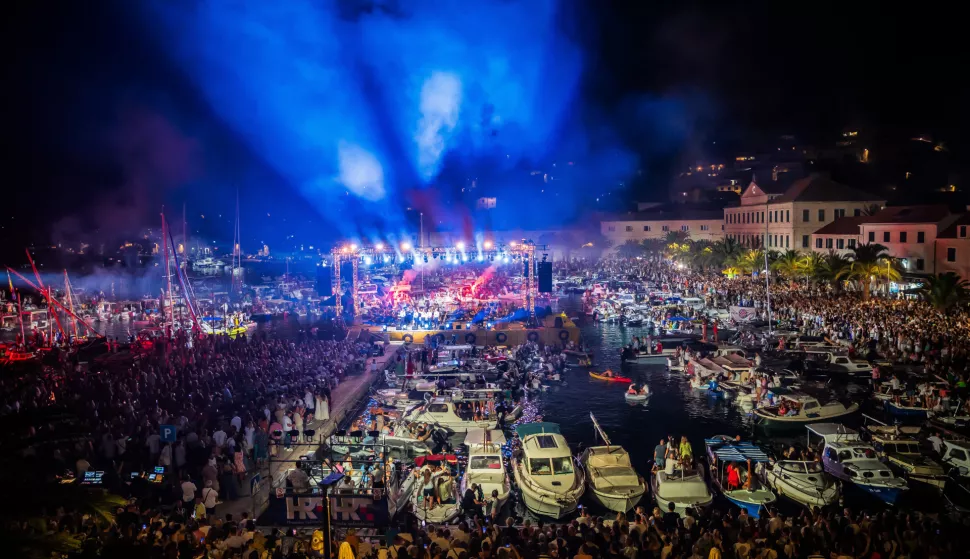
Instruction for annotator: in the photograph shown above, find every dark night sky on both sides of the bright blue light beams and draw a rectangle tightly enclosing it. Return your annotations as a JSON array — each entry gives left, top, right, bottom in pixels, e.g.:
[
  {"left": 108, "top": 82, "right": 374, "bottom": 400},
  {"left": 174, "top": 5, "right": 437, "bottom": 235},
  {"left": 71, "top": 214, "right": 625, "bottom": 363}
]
[{"left": 0, "top": 0, "right": 970, "bottom": 260}]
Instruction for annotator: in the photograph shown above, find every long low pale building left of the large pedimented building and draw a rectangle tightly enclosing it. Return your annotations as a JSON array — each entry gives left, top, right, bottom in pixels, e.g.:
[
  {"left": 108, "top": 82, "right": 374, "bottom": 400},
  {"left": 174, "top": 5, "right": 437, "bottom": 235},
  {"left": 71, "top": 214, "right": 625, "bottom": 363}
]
[{"left": 600, "top": 207, "right": 724, "bottom": 246}]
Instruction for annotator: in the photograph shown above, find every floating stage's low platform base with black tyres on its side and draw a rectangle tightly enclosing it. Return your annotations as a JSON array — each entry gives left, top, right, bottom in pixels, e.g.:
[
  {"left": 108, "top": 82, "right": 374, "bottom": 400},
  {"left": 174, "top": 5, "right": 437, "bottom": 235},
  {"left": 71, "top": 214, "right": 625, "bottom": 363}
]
[{"left": 355, "top": 315, "right": 579, "bottom": 346}]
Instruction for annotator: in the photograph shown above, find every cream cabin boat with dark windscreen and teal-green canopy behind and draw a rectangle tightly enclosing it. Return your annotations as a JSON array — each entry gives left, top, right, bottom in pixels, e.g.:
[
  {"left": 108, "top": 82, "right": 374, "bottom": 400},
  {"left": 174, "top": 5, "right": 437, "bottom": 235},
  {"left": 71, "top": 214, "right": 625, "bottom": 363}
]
[{"left": 512, "top": 423, "right": 586, "bottom": 518}]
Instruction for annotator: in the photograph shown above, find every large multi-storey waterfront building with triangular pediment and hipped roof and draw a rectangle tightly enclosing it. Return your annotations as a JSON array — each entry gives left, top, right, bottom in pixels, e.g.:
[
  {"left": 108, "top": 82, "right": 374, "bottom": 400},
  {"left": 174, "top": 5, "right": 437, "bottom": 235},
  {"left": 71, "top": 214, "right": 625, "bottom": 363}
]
[{"left": 724, "top": 174, "right": 886, "bottom": 251}]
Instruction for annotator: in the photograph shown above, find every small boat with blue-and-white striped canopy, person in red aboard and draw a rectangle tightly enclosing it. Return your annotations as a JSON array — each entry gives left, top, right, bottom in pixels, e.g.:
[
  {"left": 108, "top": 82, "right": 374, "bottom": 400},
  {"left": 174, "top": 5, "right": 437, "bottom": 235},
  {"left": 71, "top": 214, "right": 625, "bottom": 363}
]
[{"left": 704, "top": 435, "right": 777, "bottom": 518}]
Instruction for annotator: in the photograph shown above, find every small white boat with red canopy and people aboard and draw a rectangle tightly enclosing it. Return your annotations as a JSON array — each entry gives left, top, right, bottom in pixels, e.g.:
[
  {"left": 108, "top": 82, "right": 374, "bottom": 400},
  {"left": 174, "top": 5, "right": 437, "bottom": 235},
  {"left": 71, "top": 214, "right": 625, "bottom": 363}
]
[{"left": 411, "top": 454, "right": 461, "bottom": 524}]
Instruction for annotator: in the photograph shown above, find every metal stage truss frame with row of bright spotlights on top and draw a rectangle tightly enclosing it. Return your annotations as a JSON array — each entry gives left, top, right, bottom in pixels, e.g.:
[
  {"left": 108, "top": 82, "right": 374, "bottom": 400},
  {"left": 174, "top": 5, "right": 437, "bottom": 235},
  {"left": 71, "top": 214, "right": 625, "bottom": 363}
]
[{"left": 330, "top": 240, "right": 548, "bottom": 319}]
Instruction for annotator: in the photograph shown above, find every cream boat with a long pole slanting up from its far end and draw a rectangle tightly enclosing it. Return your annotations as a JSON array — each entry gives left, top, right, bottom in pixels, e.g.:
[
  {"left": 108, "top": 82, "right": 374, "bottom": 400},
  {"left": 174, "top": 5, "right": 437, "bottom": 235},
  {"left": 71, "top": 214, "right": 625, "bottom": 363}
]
[{"left": 579, "top": 413, "right": 647, "bottom": 513}]
